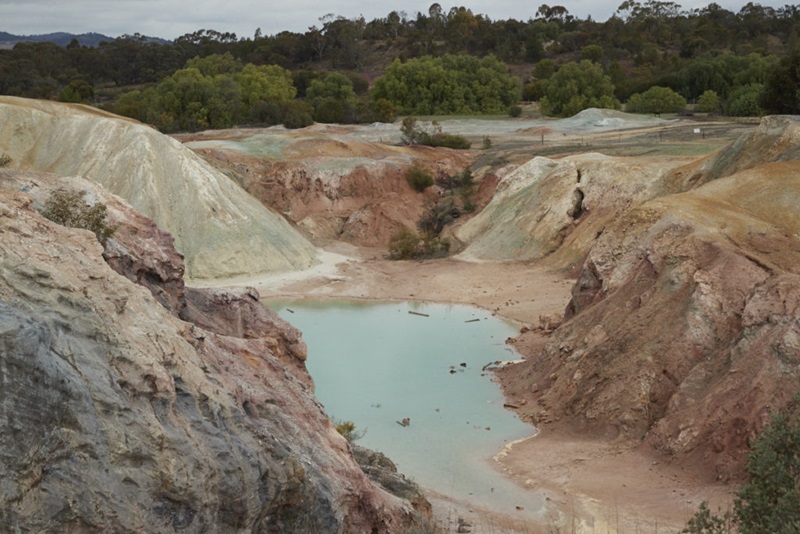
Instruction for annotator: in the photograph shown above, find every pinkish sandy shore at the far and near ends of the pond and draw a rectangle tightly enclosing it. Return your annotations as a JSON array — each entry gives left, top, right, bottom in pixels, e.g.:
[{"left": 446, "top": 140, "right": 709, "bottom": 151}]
[{"left": 194, "top": 244, "right": 735, "bottom": 533}]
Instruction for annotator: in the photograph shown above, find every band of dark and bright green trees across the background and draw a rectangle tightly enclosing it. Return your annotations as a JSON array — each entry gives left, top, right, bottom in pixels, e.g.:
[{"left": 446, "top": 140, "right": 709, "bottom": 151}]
[{"left": 0, "top": 0, "right": 800, "bottom": 131}]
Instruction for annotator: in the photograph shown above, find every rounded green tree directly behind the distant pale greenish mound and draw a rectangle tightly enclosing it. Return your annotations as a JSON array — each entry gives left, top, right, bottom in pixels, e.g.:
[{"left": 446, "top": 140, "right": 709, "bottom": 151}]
[{"left": 540, "top": 59, "right": 620, "bottom": 117}]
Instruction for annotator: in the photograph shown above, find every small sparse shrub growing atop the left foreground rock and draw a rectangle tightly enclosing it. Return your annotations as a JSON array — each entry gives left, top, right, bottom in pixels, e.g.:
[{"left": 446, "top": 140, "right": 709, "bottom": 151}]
[{"left": 41, "top": 189, "right": 116, "bottom": 246}]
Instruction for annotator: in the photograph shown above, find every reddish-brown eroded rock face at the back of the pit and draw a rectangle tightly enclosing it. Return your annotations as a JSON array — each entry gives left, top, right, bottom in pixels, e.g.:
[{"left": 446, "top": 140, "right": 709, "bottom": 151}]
[{"left": 180, "top": 125, "right": 473, "bottom": 246}]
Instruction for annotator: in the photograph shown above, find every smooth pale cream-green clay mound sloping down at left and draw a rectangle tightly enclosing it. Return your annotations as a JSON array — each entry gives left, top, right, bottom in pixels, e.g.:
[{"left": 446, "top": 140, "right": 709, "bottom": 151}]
[{"left": 0, "top": 97, "right": 316, "bottom": 278}]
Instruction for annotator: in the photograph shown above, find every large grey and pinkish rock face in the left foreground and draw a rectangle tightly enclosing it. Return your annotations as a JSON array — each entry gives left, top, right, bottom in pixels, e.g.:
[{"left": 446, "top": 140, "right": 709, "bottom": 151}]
[{"left": 0, "top": 172, "right": 432, "bottom": 532}]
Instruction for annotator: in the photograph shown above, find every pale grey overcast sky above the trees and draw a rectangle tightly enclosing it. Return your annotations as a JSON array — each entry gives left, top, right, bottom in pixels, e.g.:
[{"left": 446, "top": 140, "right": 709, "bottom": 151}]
[{"left": 0, "top": 0, "right": 794, "bottom": 39}]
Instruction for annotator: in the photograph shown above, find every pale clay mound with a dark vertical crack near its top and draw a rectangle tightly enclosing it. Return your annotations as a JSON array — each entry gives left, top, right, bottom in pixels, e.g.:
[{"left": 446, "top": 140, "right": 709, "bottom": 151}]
[{"left": 456, "top": 153, "right": 685, "bottom": 267}]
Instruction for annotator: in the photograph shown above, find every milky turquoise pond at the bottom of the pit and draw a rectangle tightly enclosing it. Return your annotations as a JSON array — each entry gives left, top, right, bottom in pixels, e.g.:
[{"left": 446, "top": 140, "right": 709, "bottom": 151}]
[{"left": 270, "top": 300, "right": 543, "bottom": 512}]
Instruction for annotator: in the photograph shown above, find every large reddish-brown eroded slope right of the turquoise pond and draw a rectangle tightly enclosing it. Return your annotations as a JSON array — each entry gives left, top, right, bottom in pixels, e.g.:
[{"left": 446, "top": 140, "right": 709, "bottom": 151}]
[{"left": 500, "top": 117, "right": 800, "bottom": 479}]
